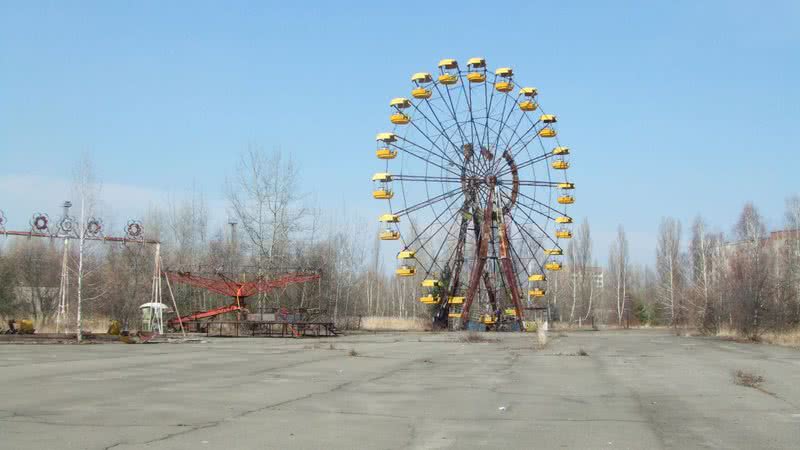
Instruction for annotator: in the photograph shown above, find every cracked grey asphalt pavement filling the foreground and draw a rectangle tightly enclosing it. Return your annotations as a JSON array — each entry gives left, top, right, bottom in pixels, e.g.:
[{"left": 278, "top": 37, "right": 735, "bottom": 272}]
[{"left": 0, "top": 330, "right": 800, "bottom": 450}]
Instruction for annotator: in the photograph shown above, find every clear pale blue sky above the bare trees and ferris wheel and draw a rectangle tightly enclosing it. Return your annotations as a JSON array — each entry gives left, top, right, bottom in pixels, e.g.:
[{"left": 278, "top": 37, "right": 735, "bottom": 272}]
[{"left": 0, "top": 1, "right": 800, "bottom": 262}]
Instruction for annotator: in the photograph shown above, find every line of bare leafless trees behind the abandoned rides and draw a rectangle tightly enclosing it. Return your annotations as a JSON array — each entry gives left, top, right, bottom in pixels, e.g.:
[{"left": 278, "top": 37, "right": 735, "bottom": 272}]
[{"left": 0, "top": 149, "right": 800, "bottom": 336}]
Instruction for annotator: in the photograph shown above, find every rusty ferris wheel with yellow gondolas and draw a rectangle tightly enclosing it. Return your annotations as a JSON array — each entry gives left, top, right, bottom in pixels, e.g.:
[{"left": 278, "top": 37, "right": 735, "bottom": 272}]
[{"left": 372, "top": 58, "right": 575, "bottom": 330}]
